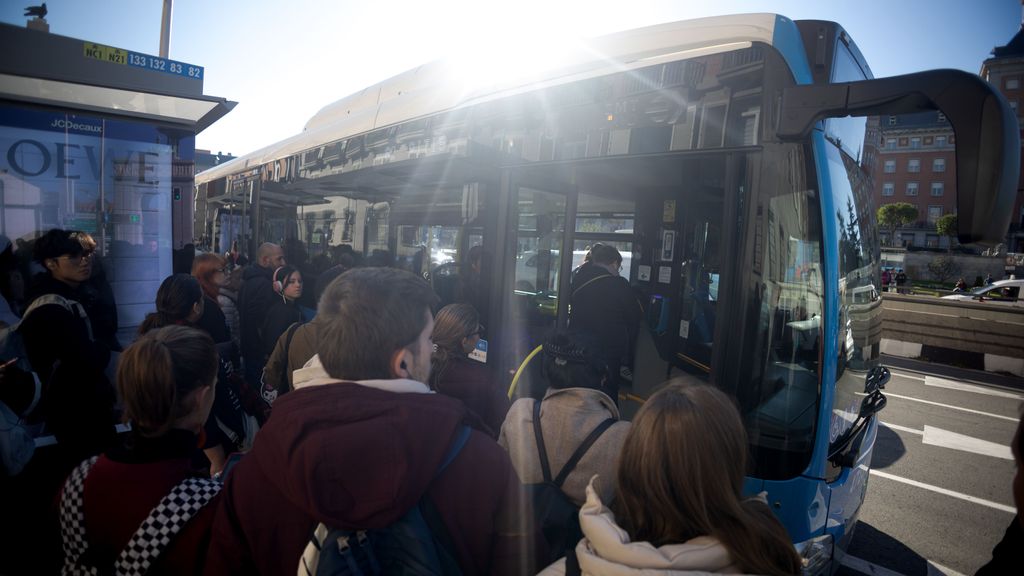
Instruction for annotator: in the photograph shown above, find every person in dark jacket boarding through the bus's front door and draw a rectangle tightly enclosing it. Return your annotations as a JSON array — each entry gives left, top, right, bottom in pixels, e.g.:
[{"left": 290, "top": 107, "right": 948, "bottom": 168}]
[{"left": 569, "top": 244, "right": 642, "bottom": 404}]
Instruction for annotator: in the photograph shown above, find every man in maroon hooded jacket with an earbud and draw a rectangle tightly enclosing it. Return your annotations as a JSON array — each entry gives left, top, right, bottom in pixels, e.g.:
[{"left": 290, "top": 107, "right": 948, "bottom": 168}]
[{"left": 206, "top": 269, "right": 547, "bottom": 575}]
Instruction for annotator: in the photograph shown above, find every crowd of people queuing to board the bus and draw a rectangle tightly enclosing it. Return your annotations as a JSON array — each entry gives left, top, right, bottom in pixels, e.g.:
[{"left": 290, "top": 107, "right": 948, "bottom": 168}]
[{"left": 0, "top": 230, "right": 1024, "bottom": 575}]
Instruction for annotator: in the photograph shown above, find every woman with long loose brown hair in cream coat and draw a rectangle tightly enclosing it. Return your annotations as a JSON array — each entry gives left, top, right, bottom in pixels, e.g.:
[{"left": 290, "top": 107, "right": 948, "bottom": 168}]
[{"left": 544, "top": 378, "right": 801, "bottom": 575}]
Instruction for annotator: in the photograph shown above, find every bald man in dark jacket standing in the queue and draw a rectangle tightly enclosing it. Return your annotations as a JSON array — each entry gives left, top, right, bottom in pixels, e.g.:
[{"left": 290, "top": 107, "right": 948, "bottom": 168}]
[{"left": 239, "top": 242, "right": 286, "bottom": 384}]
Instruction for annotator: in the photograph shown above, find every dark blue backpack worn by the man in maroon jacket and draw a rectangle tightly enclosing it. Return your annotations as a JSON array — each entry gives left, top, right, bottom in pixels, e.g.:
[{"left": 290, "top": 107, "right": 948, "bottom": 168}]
[{"left": 298, "top": 425, "right": 471, "bottom": 576}]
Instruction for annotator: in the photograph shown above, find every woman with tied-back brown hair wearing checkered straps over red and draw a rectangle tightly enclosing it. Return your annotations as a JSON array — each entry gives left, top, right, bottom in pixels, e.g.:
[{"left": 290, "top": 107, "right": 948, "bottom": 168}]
[{"left": 60, "top": 326, "right": 219, "bottom": 574}]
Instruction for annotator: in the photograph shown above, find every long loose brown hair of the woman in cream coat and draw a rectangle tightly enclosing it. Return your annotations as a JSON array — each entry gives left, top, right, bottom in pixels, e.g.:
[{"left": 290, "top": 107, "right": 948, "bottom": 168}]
[{"left": 614, "top": 376, "right": 800, "bottom": 575}]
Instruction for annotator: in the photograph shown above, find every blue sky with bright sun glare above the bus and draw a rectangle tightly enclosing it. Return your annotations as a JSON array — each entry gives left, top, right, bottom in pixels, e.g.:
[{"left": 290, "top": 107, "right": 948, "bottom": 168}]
[{"left": 0, "top": 0, "right": 1022, "bottom": 156}]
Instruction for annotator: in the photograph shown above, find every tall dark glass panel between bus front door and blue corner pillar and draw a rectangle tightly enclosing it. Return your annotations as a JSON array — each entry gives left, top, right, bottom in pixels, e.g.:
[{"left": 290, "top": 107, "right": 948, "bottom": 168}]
[{"left": 733, "top": 146, "right": 831, "bottom": 480}]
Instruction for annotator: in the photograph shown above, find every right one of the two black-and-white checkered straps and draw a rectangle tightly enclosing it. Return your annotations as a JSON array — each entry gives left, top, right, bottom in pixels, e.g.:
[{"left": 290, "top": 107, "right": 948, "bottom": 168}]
[{"left": 115, "top": 478, "right": 221, "bottom": 576}]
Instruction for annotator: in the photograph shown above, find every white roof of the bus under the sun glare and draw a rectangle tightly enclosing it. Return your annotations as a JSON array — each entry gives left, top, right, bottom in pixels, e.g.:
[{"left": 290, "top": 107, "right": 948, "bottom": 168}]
[{"left": 196, "top": 13, "right": 799, "bottom": 184}]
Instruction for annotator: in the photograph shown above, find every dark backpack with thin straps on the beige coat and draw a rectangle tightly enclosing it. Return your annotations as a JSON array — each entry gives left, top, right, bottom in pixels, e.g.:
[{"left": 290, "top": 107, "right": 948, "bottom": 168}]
[{"left": 524, "top": 401, "right": 616, "bottom": 558}]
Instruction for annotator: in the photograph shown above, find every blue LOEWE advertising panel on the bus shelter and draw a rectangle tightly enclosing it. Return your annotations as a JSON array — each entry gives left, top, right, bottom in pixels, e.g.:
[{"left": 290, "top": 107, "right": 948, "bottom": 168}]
[{"left": 0, "top": 107, "right": 180, "bottom": 338}]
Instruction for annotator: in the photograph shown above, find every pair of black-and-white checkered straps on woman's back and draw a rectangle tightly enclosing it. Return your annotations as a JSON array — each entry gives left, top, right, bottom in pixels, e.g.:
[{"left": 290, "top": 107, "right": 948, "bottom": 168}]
[{"left": 60, "top": 456, "right": 220, "bottom": 576}]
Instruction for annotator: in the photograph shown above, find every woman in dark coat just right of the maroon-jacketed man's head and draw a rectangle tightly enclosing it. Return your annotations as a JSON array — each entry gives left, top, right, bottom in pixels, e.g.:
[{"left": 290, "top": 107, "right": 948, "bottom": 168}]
[{"left": 427, "top": 303, "right": 510, "bottom": 439}]
